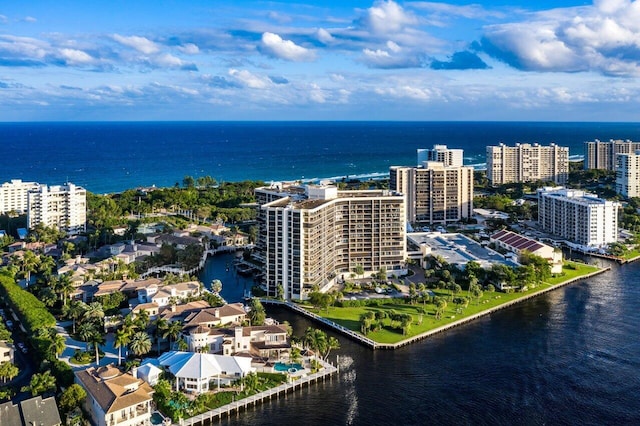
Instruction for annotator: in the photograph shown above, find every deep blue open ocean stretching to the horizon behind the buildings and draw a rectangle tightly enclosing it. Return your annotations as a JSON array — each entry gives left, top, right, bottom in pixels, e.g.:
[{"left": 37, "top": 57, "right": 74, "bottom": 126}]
[{"left": 0, "top": 122, "right": 640, "bottom": 193}]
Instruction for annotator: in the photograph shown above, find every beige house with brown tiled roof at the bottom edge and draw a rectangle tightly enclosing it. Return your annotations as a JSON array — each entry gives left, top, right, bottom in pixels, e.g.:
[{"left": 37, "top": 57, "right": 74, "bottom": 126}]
[{"left": 75, "top": 365, "right": 153, "bottom": 426}]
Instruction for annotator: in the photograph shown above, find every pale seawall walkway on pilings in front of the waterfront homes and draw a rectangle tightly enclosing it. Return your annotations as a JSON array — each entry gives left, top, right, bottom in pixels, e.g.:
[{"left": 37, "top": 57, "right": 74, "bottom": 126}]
[{"left": 174, "top": 359, "right": 339, "bottom": 426}]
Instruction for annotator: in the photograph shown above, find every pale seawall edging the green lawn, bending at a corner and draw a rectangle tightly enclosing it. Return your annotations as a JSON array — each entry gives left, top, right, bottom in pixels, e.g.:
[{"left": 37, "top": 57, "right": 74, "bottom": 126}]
[{"left": 260, "top": 266, "right": 608, "bottom": 350}]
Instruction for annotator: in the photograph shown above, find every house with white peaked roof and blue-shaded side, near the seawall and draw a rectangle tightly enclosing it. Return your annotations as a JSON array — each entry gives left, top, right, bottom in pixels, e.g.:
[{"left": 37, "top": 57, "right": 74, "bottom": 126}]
[{"left": 158, "top": 351, "right": 255, "bottom": 394}]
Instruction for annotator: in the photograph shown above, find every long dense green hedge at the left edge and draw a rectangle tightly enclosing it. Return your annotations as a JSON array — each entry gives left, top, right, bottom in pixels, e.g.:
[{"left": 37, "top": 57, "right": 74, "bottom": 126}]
[{"left": 0, "top": 271, "right": 56, "bottom": 336}]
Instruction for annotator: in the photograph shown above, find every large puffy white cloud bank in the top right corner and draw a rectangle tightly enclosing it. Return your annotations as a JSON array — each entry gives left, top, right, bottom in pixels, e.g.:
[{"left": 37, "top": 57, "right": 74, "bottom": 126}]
[{"left": 485, "top": 0, "right": 640, "bottom": 75}]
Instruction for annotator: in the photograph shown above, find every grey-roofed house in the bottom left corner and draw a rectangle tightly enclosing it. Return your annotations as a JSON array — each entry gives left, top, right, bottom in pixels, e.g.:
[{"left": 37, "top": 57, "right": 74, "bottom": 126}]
[{"left": 0, "top": 395, "right": 62, "bottom": 426}]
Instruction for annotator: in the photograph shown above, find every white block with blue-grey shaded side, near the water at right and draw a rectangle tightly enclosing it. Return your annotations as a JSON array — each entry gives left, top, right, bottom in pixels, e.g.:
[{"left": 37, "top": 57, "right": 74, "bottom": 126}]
[{"left": 538, "top": 187, "right": 620, "bottom": 247}]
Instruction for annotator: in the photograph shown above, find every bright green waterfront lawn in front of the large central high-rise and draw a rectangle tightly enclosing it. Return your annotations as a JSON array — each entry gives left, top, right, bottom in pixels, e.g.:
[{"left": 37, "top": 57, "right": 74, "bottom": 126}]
[{"left": 307, "top": 262, "right": 598, "bottom": 343}]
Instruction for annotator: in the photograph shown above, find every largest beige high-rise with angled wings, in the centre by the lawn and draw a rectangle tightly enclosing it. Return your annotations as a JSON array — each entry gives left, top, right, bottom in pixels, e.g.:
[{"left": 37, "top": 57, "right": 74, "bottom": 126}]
[{"left": 256, "top": 186, "right": 406, "bottom": 300}]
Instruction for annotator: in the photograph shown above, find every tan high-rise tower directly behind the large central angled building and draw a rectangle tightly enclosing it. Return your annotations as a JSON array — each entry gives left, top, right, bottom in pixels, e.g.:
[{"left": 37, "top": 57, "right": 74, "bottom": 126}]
[{"left": 389, "top": 161, "right": 473, "bottom": 224}]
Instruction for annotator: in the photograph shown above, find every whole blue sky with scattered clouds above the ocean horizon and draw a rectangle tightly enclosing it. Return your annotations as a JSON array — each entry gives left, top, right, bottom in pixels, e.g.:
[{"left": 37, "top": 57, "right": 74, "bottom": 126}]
[{"left": 0, "top": 0, "right": 640, "bottom": 122}]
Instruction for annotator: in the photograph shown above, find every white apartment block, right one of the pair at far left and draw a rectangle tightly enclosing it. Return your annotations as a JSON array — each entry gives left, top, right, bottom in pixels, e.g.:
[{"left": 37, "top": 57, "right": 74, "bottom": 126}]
[{"left": 27, "top": 183, "right": 87, "bottom": 235}]
